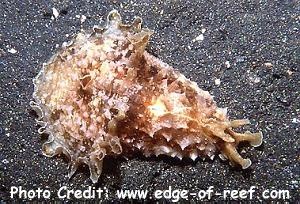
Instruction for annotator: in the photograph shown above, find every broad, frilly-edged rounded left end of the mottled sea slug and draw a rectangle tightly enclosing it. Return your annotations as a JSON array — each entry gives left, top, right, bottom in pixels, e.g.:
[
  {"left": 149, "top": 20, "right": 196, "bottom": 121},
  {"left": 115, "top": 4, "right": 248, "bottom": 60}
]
[{"left": 31, "top": 10, "right": 152, "bottom": 182}]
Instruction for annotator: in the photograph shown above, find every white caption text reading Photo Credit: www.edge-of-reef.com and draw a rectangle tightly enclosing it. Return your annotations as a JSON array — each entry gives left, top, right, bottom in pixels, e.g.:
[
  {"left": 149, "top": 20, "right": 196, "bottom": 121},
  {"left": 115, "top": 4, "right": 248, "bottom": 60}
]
[{"left": 10, "top": 186, "right": 291, "bottom": 202}]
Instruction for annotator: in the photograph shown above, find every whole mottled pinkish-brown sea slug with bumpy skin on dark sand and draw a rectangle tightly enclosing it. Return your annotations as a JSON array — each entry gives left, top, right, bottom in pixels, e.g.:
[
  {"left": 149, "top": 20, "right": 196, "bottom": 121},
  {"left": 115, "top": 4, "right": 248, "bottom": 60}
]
[{"left": 31, "top": 11, "right": 262, "bottom": 182}]
